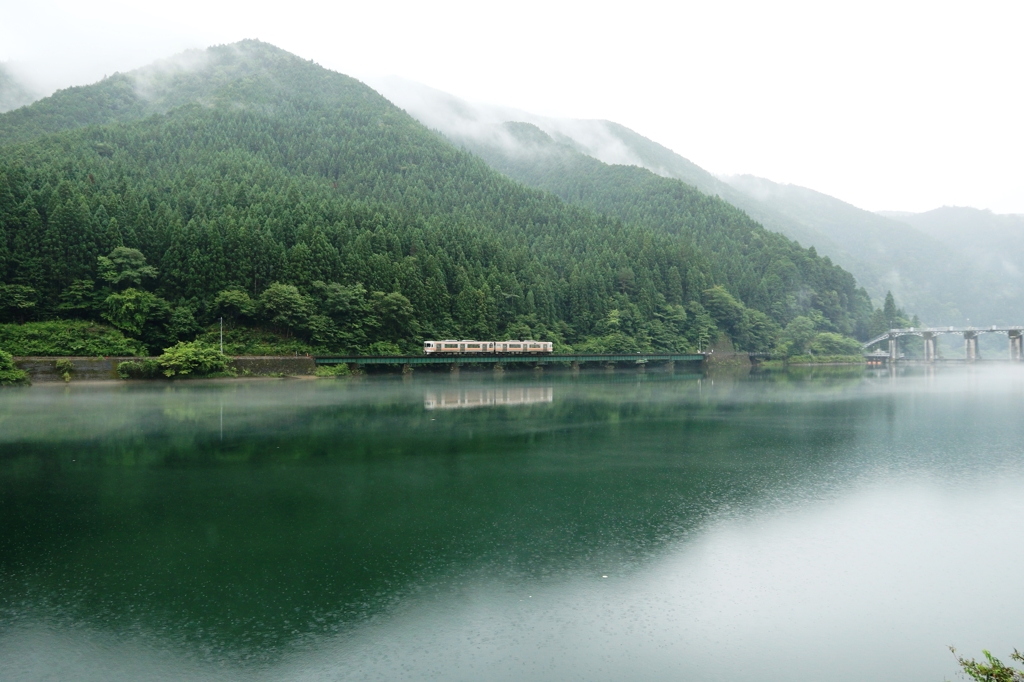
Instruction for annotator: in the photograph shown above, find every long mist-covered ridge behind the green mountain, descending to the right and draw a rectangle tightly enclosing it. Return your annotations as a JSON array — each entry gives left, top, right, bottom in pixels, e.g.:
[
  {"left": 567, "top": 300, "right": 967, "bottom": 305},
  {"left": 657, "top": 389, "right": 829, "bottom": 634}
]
[{"left": 374, "top": 79, "right": 1024, "bottom": 324}]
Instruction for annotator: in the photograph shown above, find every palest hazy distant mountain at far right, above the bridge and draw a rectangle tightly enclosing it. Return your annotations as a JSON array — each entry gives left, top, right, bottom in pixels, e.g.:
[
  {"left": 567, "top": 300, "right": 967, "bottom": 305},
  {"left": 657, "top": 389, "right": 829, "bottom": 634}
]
[{"left": 726, "top": 175, "right": 1024, "bottom": 325}]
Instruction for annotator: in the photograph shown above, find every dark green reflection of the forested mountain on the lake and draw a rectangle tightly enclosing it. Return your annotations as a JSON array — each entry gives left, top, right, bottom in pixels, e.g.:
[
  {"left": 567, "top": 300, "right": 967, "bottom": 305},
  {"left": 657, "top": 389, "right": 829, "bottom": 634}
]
[{"left": 0, "top": 375, "right": 877, "bottom": 655}]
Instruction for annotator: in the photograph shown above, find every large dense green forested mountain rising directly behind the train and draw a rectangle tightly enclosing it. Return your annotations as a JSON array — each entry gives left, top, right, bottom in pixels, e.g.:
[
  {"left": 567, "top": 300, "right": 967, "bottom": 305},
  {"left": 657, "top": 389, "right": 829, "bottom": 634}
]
[{"left": 0, "top": 41, "right": 871, "bottom": 351}]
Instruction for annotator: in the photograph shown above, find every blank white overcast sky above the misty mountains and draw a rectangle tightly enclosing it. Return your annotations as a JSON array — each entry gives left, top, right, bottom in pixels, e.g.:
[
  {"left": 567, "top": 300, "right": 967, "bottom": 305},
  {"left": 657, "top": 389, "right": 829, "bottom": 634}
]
[{"left": 0, "top": 0, "right": 1024, "bottom": 213}]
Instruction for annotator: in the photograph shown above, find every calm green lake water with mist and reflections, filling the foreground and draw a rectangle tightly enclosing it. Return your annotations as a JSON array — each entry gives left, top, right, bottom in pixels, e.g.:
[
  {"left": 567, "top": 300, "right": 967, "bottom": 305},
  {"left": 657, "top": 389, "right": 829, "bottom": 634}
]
[{"left": 0, "top": 366, "right": 1024, "bottom": 682}]
